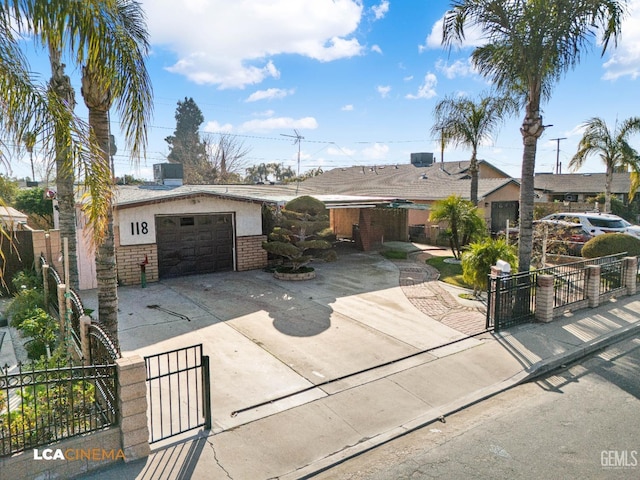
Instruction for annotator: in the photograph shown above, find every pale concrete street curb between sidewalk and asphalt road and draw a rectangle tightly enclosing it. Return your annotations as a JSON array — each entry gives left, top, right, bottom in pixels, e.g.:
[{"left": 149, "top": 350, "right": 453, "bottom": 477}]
[{"left": 278, "top": 322, "right": 640, "bottom": 480}]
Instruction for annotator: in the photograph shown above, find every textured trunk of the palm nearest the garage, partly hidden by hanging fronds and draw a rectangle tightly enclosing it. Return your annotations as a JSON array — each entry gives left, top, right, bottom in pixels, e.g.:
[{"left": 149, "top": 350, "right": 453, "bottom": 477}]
[{"left": 82, "top": 67, "right": 118, "bottom": 342}]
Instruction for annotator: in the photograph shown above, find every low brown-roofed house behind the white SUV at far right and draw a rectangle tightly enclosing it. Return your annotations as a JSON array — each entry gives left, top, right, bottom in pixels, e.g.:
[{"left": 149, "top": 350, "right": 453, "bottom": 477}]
[{"left": 534, "top": 173, "right": 631, "bottom": 204}]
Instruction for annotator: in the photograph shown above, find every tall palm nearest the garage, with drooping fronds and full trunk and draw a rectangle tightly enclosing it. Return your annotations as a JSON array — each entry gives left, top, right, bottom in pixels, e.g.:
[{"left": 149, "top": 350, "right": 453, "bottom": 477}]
[{"left": 24, "top": 0, "right": 152, "bottom": 340}]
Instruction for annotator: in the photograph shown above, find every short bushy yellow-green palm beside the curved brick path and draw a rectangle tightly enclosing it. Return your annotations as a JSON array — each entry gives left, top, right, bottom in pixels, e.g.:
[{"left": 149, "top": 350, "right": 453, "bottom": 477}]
[{"left": 429, "top": 195, "right": 487, "bottom": 259}]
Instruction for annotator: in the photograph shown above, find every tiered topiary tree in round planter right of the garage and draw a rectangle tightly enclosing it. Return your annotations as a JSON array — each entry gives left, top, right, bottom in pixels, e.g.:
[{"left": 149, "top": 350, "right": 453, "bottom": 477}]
[{"left": 262, "top": 195, "right": 335, "bottom": 280}]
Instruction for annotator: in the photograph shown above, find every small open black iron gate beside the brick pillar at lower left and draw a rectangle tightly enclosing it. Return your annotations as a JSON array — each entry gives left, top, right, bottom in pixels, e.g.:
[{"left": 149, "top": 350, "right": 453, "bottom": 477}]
[{"left": 144, "top": 344, "right": 211, "bottom": 443}]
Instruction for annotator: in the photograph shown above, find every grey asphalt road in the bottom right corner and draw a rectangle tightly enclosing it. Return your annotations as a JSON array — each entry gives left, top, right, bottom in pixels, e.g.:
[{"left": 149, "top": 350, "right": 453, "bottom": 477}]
[{"left": 314, "top": 338, "right": 640, "bottom": 480}]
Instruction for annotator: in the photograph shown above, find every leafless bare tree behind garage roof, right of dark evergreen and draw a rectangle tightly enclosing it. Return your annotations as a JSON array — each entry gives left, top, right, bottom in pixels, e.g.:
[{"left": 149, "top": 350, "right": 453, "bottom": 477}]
[{"left": 203, "top": 133, "right": 251, "bottom": 183}]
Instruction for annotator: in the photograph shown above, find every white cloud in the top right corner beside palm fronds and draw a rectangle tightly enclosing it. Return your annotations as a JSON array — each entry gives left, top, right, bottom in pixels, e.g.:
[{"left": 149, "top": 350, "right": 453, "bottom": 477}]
[{"left": 602, "top": 0, "right": 640, "bottom": 80}]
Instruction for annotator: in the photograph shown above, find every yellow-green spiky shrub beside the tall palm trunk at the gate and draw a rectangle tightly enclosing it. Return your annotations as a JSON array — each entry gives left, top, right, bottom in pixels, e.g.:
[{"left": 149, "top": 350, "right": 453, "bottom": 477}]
[{"left": 462, "top": 239, "right": 518, "bottom": 292}]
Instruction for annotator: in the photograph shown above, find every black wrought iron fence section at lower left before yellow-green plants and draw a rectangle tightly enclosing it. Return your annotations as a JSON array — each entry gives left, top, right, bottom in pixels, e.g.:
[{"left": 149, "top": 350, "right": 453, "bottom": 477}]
[{"left": 0, "top": 364, "right": 118, "bottom": 456}]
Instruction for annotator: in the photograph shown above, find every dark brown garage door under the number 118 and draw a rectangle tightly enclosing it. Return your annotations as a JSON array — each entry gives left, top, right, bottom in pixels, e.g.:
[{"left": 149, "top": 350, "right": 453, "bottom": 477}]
[{"left": 156, "top": 214, "right": 233, "bottom": 278}]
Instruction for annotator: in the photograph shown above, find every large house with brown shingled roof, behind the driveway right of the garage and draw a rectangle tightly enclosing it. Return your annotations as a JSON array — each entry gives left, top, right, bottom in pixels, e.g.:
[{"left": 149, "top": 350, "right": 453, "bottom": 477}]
[{"left": 301, "top": 160, "right": 520, "bottom": 236}]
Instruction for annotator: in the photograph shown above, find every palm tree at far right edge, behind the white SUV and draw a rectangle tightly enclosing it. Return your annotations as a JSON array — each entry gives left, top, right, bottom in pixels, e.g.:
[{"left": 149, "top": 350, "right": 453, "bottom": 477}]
[{"left": 569, "top": 117, "right": 640, "bottom": 212}]
